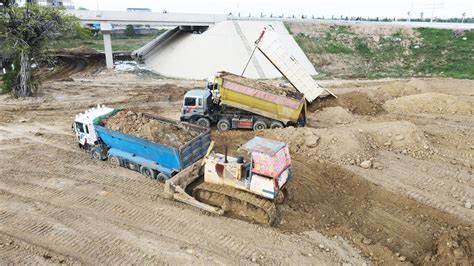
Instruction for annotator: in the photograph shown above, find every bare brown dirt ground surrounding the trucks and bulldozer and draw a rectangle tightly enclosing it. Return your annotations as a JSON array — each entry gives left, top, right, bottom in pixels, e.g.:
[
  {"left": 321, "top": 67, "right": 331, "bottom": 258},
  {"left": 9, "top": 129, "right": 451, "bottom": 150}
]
[{"left": 0, "top": 69, "right": 474, "bottom": 265}]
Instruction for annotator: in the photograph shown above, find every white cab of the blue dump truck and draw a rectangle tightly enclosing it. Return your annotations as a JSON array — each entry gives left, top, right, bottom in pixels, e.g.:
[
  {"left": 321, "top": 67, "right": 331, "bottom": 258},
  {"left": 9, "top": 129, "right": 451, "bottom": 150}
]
[{"left": 72, "top": 105, "right": 114, "bottom": 150}]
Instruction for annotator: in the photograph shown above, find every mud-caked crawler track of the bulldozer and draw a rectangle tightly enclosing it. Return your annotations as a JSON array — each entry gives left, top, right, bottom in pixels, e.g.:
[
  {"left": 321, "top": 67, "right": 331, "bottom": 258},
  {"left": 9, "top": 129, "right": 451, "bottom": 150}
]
[{"left": 193, "top": 182, "right": 277, "bottom": 225}]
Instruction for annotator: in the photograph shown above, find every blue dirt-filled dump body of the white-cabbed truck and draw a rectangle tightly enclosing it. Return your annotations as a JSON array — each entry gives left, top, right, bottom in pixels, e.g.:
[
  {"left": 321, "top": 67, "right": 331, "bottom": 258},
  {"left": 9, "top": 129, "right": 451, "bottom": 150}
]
[{"left": 94, "top": 114, "right": 211, "bottom": 178}]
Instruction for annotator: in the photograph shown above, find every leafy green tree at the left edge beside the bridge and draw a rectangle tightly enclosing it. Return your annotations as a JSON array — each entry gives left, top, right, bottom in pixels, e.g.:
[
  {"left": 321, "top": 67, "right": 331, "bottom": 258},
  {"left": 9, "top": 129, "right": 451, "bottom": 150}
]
[{"left": 0, "top": 4, "right": 81, "bottom": 97}]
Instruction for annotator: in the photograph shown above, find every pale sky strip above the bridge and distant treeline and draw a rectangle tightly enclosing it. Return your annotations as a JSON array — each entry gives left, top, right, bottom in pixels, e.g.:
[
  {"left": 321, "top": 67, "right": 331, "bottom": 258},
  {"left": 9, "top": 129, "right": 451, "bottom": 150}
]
[{"left": 72, "top": 0, "right": 474, "bottom": 18}]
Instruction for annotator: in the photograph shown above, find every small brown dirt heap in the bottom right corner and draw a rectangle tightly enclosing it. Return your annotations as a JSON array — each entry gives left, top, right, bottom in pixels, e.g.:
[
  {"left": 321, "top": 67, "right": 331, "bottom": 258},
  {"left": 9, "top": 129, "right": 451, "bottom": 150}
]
[{"left": 424, "top": 232, "right": 474, "bottom": 265}]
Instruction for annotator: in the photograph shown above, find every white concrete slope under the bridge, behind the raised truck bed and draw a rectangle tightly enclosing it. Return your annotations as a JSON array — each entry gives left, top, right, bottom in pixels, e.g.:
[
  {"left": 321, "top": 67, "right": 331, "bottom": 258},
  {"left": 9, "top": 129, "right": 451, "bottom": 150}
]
[{"left": 141, "top": 21, "right": 317, "bottom": 79}]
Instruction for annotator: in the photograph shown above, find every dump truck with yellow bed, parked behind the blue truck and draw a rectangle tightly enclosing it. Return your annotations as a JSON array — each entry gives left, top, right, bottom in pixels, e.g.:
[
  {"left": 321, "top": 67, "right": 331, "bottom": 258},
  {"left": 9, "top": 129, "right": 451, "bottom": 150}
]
[{"left": 181, "top": 72, "right": 306, "bottom": 131}]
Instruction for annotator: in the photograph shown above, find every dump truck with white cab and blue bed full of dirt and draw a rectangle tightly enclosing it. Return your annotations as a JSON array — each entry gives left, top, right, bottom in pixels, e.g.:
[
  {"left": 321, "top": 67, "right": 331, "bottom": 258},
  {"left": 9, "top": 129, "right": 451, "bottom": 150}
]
[{"left": 73, "top": 106, "right": 211, "bottom": 180}]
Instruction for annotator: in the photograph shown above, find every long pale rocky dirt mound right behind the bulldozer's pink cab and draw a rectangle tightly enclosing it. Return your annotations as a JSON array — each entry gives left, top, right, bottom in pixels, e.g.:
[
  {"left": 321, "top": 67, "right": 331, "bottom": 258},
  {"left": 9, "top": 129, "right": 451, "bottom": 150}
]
[{"left": 264, "top": 121, "right": 434, "bottom": 165}]
